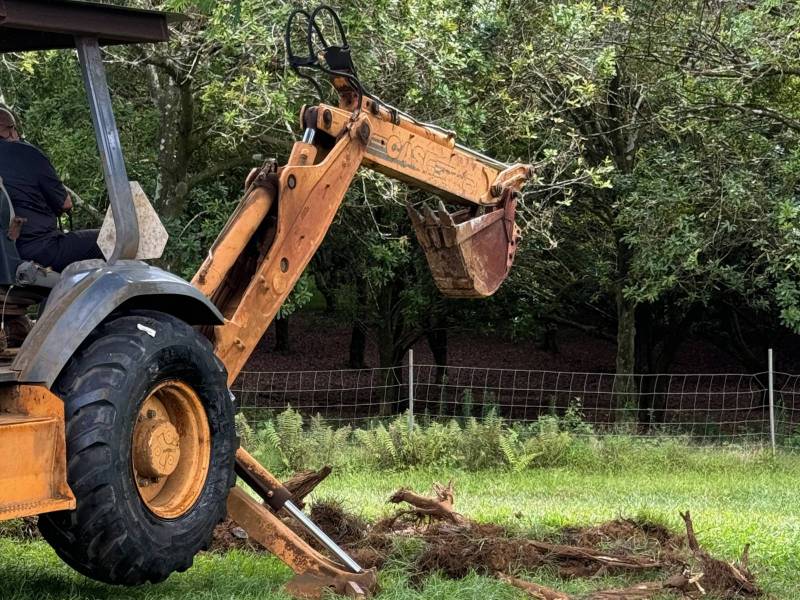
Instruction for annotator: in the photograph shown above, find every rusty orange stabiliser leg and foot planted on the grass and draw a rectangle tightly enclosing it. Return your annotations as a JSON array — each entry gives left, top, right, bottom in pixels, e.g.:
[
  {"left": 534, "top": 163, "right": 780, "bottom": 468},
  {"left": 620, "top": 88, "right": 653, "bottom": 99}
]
[{"left": 228, "top": 488, "right": 377, "bottom": 600}]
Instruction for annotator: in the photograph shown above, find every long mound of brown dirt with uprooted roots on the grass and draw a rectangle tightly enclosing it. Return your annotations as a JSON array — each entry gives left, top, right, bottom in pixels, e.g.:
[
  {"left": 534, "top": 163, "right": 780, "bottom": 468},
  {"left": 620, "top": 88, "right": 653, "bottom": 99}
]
[{"left": 205, "top": 476, "right": 761, "bottom": 600}]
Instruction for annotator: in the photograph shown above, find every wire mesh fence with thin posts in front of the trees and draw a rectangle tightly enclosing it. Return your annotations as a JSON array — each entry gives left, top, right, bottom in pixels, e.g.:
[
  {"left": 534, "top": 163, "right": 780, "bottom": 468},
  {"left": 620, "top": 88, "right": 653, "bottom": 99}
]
[{"left": 233, "top": 358, "right": 800, "bottom": 447}]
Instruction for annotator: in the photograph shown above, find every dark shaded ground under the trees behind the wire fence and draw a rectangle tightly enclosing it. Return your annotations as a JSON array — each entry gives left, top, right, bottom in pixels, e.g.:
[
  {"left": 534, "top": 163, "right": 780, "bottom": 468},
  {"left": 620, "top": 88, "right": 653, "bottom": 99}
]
[{"left": 233, "top": 313, "right": 800, "bottom": 441}]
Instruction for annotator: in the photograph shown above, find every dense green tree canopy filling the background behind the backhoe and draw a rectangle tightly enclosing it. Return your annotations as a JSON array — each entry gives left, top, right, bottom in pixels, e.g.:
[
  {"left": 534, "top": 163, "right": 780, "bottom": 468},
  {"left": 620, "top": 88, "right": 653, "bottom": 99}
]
[{"left": 0, "top": 0, "right": 800, "bottom": 410}]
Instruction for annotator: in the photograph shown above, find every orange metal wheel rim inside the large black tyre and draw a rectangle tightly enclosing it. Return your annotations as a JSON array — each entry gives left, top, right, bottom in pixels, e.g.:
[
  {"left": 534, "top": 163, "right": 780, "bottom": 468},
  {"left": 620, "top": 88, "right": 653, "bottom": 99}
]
[{"left": 131, "top": 381, "right": 211, "bottom": 519}]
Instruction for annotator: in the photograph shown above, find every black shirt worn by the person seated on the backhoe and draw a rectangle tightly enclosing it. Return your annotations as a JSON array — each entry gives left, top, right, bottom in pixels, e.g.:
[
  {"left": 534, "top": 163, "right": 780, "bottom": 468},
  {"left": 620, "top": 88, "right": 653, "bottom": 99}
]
[{"left": 0, "top": 140, "right": 67, "bottom": 249}]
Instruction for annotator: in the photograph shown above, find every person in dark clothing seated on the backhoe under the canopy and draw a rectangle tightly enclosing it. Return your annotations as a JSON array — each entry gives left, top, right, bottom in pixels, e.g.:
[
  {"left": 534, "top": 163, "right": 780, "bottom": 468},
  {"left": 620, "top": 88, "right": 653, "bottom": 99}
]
[{"left": 0, "top": 107, "right": 103, "bottom": 272}]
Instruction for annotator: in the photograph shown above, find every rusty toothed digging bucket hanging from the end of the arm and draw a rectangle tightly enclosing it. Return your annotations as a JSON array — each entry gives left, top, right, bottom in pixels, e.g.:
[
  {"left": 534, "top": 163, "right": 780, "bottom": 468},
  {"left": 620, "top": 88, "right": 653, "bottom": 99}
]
[{"left": 407, "top": 189, "right": 519, "bottom": 298}]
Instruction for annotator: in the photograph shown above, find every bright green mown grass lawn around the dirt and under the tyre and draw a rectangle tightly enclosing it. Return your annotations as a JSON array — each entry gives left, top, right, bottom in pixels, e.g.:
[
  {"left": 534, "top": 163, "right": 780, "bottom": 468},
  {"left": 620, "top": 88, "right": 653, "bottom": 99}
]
[{"left": 0, "top": 451, "right": 800, "bottom": 600}]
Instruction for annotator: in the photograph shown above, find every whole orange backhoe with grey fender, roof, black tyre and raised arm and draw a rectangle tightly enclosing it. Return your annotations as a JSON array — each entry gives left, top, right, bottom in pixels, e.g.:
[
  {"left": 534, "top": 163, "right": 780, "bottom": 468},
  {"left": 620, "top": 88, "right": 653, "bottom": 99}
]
[{"left": 0, "top": 0, "right": 531, "bottom": 598}]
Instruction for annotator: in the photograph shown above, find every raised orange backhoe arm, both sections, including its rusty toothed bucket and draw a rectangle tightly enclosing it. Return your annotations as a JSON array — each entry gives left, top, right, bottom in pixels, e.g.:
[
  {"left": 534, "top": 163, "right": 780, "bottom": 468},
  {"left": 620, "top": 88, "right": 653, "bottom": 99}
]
[{"left": 192, "top": 99, "right": 530, "bottom": 382}]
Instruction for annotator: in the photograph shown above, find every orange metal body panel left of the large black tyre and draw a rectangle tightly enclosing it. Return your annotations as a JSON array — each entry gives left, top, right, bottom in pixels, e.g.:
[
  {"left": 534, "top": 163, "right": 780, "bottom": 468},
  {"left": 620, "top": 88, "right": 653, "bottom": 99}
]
[{"left": 0, "top": 385, "right": 75, "bottom": 520}]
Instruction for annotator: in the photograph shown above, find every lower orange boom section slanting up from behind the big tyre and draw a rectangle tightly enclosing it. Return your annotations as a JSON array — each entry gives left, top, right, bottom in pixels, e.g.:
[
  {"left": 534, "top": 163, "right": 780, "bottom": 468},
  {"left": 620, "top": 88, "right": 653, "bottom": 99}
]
[{"left": 205, "top": 115, "right": 368, "bottom": 383}]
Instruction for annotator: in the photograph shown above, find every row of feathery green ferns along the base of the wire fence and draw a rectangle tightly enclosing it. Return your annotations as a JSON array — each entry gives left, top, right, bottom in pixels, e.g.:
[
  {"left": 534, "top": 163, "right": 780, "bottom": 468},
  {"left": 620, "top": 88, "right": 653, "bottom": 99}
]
[{"left": 249, "top": 407, "right": 592, "bottom": 471}]
